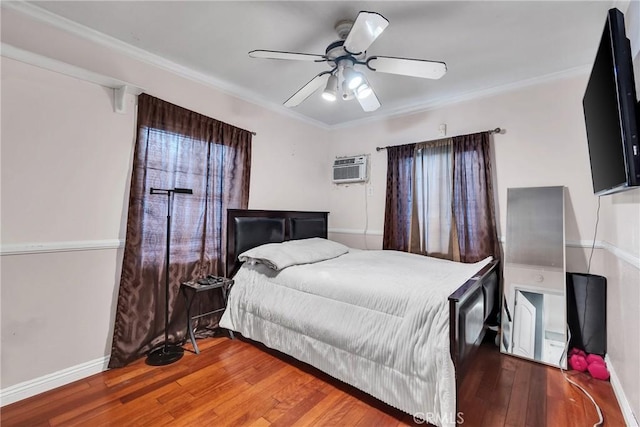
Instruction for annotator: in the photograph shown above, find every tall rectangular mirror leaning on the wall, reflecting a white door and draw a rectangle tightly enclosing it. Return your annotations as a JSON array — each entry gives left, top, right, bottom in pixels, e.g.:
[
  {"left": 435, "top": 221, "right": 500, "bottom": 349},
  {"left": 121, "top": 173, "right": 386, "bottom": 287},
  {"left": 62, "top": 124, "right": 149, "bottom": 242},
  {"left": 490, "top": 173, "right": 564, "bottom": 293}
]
[{"left": 500, "top": 187, "right": 566, "bottom": 367}]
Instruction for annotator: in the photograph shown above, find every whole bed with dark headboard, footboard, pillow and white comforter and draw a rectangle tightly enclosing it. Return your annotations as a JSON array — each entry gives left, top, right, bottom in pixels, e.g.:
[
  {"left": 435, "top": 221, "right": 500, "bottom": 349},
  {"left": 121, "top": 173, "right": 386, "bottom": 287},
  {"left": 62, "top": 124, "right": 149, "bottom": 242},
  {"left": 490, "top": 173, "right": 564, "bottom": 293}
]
[{"left": 220, "top": 210, "right": 498, "bottom": 425}]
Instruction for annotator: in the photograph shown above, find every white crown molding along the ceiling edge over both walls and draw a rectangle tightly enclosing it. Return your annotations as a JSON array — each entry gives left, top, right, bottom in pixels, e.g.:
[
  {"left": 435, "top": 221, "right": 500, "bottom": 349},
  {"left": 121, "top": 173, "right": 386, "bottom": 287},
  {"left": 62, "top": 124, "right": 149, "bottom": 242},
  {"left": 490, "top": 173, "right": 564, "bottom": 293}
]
[{"left": 1, "top": 1, "right": 592, "bottom": 130}]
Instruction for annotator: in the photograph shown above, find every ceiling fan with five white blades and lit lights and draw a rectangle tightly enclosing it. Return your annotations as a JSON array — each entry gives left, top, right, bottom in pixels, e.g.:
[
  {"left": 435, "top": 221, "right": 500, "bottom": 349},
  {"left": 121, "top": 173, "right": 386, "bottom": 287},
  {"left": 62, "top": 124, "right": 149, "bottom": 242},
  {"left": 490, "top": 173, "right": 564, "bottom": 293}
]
[{"left": 249, "top": 11, "right": 447, "bottom": 111}]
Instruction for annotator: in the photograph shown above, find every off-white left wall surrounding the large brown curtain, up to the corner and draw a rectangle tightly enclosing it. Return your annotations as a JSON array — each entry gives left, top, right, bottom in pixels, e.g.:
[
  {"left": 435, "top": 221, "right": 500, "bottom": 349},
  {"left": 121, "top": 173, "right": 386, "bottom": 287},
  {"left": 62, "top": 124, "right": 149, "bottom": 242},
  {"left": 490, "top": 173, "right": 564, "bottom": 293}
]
[{"left": 0, "top": 9, "right": 329, "bottom": 404}]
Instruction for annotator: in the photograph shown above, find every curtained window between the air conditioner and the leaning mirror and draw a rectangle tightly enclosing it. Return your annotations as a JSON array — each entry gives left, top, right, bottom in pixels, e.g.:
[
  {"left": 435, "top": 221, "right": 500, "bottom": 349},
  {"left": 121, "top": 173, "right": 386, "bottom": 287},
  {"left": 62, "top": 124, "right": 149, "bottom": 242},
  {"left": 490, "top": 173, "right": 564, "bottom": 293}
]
[{"left": 383, "top": 132, "right": 500, "bottom": 262}]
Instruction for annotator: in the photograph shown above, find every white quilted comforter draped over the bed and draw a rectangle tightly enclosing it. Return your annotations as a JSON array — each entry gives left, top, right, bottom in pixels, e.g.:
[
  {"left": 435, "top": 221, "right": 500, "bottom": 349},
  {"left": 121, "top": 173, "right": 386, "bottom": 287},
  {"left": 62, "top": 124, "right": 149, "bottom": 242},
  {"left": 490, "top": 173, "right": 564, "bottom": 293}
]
[{"left": 220, "top": 251, "right": 491, "bottom": 425}]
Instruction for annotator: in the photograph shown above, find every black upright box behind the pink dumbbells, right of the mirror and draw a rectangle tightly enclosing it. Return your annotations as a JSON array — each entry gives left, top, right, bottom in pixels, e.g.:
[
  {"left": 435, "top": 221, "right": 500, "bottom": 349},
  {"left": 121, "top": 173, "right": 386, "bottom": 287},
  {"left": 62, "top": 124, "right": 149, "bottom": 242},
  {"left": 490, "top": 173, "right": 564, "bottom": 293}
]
[{"left": 567, "top": 273, "right": 607, "bottom": 356}]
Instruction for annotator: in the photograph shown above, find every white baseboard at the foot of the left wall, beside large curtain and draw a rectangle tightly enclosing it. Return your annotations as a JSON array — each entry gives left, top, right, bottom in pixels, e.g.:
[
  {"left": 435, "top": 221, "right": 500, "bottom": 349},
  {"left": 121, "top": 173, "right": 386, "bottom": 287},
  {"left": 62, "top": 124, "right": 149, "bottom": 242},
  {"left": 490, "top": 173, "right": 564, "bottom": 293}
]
[{"left": 0, "top": 356, "right": 109, "bottom": 406}]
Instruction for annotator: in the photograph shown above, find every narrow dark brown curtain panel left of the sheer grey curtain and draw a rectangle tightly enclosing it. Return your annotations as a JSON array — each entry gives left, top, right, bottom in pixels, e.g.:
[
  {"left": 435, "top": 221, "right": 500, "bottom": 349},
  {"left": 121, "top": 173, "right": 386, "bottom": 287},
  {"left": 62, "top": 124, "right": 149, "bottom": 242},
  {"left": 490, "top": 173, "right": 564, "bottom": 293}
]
[{"left": 382, "top": 144, "right": 415, "bottom": 251}]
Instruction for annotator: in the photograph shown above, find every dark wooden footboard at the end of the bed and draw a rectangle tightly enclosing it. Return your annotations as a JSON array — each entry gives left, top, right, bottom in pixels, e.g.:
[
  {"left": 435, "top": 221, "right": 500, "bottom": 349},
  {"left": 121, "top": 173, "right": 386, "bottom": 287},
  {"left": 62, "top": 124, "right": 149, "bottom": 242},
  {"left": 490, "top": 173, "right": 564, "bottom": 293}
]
[{"left": 449, "top": 260, "right": 500, "bottom": 389}]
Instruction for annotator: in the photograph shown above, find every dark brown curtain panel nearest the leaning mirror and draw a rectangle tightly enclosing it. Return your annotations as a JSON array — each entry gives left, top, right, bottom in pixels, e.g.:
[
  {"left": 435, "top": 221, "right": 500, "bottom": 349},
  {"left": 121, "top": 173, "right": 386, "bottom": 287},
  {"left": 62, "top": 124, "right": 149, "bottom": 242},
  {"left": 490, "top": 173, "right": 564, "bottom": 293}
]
[{"left": 453, "top": 132, "right": 500, "bottom": 262}]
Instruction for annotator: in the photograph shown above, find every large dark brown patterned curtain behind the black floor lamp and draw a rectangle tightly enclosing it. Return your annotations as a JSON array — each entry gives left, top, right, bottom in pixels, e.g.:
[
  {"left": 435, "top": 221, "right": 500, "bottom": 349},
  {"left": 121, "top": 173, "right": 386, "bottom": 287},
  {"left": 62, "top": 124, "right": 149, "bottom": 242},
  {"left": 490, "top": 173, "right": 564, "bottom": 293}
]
[{"left": 109, "top": 94, "right": 251, "bottom": 368}]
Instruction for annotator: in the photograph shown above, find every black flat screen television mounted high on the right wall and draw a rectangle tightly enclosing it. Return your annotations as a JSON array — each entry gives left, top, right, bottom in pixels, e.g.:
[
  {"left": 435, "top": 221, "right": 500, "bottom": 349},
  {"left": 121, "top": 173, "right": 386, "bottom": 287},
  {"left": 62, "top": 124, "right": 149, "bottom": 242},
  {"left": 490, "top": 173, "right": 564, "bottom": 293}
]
[{"left": 582, "top": 8, "right": 640, "bottom": 196}]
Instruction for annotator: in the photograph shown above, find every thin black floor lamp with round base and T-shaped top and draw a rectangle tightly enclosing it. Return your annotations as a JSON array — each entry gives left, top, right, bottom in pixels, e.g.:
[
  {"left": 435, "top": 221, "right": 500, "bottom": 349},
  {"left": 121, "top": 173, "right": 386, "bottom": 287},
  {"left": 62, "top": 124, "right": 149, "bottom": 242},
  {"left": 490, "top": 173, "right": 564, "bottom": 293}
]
[{"left": 146, "top": 188, "right": 193, "bottom": 366}]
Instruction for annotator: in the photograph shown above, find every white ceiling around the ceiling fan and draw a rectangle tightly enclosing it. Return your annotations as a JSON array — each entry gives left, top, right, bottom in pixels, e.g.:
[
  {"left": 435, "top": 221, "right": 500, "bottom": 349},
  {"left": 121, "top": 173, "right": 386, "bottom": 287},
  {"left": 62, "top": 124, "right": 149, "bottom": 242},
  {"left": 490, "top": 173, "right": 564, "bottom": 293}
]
[{"left": 23, "top": 1, "right": 612, "bottom": 127}]
